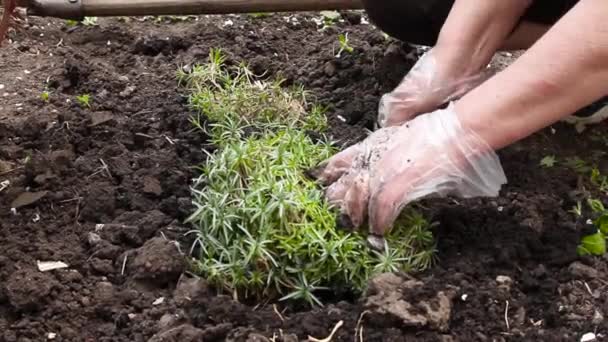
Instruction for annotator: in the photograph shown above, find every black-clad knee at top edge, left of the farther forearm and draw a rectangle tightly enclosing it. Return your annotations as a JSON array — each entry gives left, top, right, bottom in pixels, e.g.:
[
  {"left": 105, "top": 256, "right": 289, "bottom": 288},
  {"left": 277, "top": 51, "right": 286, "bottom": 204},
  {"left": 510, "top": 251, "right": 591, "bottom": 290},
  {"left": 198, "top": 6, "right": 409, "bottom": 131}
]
[{"left": 363, "top": 0, "right": 454, "bottom": 46}]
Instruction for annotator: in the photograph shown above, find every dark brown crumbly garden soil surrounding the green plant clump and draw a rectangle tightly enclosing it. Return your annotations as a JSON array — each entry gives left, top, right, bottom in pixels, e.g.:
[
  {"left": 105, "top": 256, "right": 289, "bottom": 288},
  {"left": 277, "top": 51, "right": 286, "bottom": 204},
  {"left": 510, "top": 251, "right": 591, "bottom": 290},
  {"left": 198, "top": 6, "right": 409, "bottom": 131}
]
[{"left": 0, "top": 10, "right": 608, "bottom": 342}]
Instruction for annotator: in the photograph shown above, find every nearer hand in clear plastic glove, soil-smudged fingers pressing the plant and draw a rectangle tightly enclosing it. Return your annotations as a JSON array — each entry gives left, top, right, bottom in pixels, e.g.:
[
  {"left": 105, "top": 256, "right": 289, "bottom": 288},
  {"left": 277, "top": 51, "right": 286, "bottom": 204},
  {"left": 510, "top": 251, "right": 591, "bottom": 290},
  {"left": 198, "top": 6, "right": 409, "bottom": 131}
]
[{"left": 310, "top": 105, "right": 506, "bottom": 249}]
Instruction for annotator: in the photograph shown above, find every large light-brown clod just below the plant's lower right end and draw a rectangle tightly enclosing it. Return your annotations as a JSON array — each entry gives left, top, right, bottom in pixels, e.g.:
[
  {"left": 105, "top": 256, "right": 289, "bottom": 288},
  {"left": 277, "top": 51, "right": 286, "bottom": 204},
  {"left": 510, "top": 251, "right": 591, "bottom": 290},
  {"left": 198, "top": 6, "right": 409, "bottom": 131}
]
[{"left": 364, "top": 273, "right": 456, "bottom": 331}]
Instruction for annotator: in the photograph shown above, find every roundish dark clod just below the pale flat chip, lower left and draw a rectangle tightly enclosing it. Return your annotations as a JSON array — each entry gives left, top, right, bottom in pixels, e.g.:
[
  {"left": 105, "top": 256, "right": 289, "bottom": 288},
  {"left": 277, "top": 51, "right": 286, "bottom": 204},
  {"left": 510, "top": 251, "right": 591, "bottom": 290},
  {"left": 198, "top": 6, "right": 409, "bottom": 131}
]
[{"left": 6, "top": 268, "right": 57, "bottom": 311}]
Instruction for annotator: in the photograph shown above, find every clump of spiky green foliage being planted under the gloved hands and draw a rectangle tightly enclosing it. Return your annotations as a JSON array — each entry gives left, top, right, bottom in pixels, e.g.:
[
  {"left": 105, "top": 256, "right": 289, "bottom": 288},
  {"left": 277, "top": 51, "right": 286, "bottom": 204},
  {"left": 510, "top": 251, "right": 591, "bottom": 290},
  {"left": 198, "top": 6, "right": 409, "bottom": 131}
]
[{"left": 183, "top": 50, "right": 434, "bottom": 305}]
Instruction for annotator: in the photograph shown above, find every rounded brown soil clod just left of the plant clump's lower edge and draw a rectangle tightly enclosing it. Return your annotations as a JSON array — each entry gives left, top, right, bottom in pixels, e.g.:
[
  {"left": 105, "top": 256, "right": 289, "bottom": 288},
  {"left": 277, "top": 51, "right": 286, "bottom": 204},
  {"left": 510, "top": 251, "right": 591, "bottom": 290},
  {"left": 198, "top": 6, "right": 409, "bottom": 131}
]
[{"left": 130, "top": 238, "right": 186, "bottom": 286}]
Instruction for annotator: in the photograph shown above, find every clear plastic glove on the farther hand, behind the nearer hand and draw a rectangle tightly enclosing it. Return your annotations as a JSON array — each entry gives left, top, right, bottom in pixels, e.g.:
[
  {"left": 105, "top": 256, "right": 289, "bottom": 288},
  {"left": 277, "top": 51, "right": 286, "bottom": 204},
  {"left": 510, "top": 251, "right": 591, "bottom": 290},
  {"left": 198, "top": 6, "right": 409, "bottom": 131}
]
[{"left": 378, "top": 49, "right": 490, "bottom": 127}]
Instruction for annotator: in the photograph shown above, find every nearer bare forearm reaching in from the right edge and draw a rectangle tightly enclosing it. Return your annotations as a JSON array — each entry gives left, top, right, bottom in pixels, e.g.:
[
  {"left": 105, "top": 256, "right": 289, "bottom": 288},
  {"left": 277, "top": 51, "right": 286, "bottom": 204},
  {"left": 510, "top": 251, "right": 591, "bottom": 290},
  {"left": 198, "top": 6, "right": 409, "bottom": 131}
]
[{"left": 456, "top": 0, "right": 608, "bottom": 149}]
